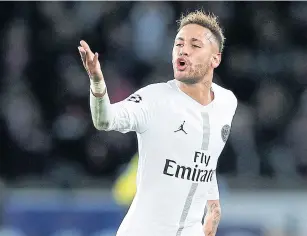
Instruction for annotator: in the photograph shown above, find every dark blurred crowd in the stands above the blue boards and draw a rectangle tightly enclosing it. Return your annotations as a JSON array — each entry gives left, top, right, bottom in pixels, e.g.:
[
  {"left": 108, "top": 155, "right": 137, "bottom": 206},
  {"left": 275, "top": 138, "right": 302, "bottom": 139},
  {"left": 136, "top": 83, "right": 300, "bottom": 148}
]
[{"left": 0, "top": 1, "right": 307, "bottom": 186}]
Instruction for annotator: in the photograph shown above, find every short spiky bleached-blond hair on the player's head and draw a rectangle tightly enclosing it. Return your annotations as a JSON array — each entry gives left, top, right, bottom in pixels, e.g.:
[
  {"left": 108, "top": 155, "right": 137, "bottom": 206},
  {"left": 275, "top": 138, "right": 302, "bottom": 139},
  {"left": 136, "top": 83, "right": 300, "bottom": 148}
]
[{"left": 177, "top": 10, "right": 225, "bottom": 52}]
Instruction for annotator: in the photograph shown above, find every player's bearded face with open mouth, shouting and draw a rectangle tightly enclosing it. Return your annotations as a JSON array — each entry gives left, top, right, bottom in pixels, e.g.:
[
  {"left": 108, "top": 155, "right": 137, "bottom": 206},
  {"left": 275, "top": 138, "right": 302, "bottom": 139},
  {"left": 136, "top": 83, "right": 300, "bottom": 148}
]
[{"left": 172, "top": 24, "right": 221, "bottom": 84}]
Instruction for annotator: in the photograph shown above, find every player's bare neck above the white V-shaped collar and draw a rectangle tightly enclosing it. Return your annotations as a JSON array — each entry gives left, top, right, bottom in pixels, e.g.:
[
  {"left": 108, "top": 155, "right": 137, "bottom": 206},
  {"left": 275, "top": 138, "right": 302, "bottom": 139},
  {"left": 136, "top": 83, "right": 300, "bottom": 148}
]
[{"left": 178, "top": 74, "right": 214, "bottom": 106}]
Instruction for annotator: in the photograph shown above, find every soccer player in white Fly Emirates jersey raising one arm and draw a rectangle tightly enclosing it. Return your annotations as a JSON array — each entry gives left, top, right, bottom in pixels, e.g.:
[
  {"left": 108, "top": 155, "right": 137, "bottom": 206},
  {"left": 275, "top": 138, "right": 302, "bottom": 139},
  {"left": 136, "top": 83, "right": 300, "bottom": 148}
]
[{"left": 78, "top": 11, "right": 237, "bottom": 236}]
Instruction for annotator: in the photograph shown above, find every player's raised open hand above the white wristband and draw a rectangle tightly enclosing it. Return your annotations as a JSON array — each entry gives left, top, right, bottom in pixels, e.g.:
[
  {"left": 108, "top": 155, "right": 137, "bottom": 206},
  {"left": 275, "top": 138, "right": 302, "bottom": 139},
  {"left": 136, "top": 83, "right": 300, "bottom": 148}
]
[{"left": 78, "top": 40, "right": 104, "bottom": 82}]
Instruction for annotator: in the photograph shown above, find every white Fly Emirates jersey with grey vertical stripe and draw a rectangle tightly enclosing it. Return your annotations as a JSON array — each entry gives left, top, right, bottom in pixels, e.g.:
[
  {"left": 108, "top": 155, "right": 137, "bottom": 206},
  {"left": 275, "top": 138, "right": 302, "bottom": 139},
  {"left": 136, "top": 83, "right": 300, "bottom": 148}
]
[{"left": 91, "top": 80, "right": 237, "bottom": 236}]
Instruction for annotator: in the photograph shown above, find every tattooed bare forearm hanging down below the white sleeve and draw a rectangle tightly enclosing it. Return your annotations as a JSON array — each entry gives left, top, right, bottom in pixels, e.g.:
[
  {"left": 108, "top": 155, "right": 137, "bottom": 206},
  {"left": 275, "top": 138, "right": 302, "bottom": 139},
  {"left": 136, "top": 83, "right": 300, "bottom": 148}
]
[{"left": 204, "top": 202, "right": 221, "bottom": 236}]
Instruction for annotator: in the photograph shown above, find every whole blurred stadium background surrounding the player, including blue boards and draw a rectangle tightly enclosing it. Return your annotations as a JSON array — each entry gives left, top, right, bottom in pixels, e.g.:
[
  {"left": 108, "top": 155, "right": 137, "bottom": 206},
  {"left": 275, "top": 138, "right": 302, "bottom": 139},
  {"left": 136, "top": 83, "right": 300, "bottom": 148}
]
[{"left": 0, "top": 1, "right": 307, "bottom": 236}]
